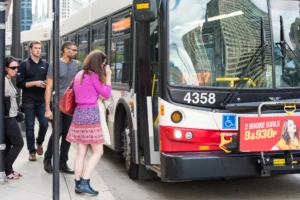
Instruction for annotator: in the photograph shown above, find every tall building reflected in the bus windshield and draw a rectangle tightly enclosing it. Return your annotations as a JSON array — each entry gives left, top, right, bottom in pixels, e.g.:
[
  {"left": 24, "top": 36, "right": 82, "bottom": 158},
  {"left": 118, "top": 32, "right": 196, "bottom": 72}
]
[{"left": 203, "top": 0, "right": 272, "bottom": 80}]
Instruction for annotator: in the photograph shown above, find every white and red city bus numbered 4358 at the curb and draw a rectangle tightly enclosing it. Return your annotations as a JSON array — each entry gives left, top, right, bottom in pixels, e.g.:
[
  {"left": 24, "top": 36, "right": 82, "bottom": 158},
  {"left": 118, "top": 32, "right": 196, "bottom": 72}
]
[{"left": 17, "top": 0, "right": 300, "bottom": 182}]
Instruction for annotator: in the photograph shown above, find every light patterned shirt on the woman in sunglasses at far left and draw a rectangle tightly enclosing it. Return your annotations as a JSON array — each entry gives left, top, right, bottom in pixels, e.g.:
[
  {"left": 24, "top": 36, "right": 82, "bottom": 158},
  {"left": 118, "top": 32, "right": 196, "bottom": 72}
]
[{"left": 5, "top": 76, "right": 18, "bottom": 117}]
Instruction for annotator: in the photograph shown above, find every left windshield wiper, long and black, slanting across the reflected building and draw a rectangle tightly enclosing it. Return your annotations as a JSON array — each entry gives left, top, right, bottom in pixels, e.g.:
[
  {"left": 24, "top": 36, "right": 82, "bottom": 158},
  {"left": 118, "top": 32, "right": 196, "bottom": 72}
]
[{"left": 221, "top": 44, "right": 268, "bottom": 107}]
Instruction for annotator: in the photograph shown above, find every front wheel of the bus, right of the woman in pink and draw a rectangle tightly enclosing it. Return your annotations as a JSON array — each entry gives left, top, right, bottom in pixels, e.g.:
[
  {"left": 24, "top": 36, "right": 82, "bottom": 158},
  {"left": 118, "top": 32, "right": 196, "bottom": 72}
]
[{"left": 122, "top": 118, "right": 138, "bottom": 179}]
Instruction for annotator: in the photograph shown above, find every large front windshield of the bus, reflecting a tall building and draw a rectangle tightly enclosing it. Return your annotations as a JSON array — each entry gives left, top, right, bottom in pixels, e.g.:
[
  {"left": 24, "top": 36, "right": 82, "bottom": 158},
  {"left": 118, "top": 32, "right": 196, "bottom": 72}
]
[{"left": 168, "top": 0, "right": 299, "bottom": 88}]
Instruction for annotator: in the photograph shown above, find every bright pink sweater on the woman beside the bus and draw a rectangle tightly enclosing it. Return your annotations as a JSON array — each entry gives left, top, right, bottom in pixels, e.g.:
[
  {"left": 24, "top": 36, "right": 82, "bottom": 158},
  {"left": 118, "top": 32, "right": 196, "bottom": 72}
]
[{"left": 74, "top": 71, "right": 111, "bottom": 108}]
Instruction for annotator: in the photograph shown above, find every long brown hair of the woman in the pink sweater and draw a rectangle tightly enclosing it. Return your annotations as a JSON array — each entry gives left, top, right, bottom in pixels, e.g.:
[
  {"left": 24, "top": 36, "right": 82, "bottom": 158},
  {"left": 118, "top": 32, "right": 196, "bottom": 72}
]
[{"left": 80, "top": 50, "right": 107, "bottom": 84}]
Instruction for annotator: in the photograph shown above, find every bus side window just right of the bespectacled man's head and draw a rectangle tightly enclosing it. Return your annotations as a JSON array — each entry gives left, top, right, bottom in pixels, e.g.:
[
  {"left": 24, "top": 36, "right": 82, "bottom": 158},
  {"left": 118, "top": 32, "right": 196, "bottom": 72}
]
[{"left": 77, "top": 30, "right": 89, "bottom": 63}]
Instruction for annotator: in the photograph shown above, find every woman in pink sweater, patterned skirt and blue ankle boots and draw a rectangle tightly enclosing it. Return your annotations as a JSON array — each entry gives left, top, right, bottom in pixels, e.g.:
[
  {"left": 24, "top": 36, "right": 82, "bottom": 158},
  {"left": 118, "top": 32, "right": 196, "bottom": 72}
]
[{"left": 67, "top": 50, "right": 111, "bottom": 195}]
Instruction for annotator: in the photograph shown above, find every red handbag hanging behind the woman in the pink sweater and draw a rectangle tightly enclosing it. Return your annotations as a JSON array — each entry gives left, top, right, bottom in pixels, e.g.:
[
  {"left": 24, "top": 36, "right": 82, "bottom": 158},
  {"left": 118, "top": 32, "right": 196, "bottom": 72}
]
[{"left": 59, "top": 79, "right": 76, "bottom": 116}]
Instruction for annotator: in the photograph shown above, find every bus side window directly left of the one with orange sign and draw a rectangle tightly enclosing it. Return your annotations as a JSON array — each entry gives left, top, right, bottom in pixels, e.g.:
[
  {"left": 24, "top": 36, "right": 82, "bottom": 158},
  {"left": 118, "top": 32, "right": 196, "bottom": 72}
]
[{"left": 92, "top": 24, "right": 105, "bottom": 53}]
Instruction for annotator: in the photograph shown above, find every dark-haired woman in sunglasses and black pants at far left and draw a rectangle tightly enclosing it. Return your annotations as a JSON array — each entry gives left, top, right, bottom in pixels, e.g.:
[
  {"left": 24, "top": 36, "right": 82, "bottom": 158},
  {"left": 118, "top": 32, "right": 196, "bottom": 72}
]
[{"left": 4, "top": 56, "right": 24, "bottom": 180}]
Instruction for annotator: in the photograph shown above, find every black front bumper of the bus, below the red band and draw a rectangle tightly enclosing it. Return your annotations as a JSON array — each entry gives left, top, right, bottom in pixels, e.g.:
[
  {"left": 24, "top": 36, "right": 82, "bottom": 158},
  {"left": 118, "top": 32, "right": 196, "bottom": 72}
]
[{"left": 161, "top": 151, "right": 300, "bottom": 181}]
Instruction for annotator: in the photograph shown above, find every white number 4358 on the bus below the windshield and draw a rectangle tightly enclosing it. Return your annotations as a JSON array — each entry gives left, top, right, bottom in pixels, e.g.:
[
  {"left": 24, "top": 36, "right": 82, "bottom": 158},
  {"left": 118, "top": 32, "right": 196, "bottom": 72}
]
[{"left": 183, "top": 92, "right": 216, "bottom": 104}]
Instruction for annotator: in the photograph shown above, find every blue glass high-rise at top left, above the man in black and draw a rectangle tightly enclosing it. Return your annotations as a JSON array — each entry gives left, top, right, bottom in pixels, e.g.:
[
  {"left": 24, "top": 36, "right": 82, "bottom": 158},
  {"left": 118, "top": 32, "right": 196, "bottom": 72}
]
[{"left": 21, "top": 0, "right": 32, "bottom": 31}]
